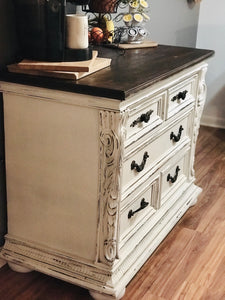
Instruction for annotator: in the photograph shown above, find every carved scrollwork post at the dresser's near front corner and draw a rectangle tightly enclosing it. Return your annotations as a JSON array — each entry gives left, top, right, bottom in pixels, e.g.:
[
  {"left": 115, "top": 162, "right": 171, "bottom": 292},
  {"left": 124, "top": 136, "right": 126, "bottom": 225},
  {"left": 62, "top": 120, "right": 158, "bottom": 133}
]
[{"left": 96, "top": 111, "right": 125, "bottom": 264}]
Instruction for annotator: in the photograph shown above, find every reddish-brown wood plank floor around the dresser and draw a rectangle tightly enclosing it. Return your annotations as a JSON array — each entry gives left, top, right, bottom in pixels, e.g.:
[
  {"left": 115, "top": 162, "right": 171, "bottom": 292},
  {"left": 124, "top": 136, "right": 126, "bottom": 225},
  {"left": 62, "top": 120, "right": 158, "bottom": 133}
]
[{"left": 0, "top": 127, "right": 225, "bottom": 300}]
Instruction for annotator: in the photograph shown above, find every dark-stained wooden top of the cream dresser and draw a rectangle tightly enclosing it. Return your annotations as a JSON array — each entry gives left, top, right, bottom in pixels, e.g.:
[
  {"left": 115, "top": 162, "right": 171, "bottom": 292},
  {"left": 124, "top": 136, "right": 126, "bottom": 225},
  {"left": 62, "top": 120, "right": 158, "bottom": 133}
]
[{"left": 0, "top": 45, "right": 214, "bottom": 100}]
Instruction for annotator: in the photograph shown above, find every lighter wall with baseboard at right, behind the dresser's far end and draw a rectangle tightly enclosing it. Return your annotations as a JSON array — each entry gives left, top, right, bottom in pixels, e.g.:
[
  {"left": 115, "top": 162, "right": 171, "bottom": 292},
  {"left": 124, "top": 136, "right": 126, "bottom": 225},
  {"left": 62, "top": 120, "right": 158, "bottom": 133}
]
[{"left": 197, "top": 0, "right": 225, "bottom": 128}]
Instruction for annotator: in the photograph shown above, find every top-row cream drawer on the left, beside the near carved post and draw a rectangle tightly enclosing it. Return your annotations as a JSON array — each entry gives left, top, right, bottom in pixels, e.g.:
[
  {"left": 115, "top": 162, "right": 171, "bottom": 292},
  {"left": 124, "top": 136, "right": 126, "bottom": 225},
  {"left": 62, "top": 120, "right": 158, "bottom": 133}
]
[{"left": 125, "top": 92, "right": 166, "bottom": 146}]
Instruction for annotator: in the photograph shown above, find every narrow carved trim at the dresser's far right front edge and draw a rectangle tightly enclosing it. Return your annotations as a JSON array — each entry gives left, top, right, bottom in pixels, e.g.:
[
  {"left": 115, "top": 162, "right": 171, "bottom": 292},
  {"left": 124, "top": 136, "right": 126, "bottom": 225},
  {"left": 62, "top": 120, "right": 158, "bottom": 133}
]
[{"left": 191, "top": 64, "right": 208, "bottom": 176}]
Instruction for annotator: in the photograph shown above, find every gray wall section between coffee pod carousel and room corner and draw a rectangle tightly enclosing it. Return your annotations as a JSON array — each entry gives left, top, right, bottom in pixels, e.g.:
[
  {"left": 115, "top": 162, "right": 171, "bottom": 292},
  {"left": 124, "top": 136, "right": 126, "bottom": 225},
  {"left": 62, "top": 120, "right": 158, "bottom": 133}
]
[{"left": 148, "top": 0, "right": 199, "bottom": 47}]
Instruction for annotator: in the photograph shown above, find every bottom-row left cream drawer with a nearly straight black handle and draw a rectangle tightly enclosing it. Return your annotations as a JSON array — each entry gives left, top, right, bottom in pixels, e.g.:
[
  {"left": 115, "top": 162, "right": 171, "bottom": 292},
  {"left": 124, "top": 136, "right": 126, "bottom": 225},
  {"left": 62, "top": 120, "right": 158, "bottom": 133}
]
[{"left": 120, "top": 175, "right": 160, "bottom": 240}]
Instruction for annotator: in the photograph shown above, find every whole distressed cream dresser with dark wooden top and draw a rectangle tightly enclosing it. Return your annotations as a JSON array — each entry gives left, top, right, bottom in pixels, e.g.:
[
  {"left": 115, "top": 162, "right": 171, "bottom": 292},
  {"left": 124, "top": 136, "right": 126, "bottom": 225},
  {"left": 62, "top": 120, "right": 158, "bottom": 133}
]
[{"left": 0, "top": 46, "right": 213, "bottom": 299}]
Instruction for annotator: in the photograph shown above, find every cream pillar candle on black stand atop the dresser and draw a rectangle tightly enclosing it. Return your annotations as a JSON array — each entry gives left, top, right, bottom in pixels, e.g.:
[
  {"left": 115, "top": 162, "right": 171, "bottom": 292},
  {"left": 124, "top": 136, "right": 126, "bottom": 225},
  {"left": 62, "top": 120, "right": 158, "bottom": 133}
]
[{"left": 66, "top": 14, "right": 88, "bottom": 49}]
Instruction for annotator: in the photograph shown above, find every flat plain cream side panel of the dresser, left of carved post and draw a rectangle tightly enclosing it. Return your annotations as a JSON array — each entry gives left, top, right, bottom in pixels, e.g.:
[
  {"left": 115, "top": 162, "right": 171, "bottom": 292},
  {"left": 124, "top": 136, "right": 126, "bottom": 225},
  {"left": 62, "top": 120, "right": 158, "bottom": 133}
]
[{"left": 4, "top": 94, "right": 98, "bottom": 260}]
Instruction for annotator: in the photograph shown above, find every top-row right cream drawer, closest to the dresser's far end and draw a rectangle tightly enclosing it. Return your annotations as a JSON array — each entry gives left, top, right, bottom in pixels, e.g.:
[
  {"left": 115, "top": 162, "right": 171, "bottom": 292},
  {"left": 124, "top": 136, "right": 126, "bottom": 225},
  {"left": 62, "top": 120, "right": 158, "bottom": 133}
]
[{"left": 167, "top": 75, "right": 197, "bottom": 118}]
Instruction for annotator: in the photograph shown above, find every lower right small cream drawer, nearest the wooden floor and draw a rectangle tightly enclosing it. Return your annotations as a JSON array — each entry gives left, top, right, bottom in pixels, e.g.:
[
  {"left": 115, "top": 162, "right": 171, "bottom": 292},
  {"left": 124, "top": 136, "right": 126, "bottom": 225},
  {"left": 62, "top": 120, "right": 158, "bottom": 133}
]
[{"left": 161, "top": 150, "right": 190, "bottom": 205}]
